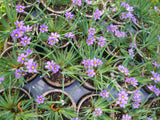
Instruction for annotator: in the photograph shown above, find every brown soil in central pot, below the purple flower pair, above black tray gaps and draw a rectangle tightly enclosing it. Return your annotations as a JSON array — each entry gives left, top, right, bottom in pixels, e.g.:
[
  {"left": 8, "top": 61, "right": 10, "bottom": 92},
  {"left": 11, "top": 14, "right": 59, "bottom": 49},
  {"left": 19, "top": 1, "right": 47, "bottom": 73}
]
[{"left": 46, "top": 71, "right": 73, "bottom": 84}]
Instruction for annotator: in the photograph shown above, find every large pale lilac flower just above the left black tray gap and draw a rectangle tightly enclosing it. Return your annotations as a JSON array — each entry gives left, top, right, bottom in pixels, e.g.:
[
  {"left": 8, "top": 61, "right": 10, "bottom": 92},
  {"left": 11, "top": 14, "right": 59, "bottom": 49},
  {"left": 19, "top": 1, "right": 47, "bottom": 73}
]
[{"left": 24, "top": 59, "right": 38, "bottom": 73}]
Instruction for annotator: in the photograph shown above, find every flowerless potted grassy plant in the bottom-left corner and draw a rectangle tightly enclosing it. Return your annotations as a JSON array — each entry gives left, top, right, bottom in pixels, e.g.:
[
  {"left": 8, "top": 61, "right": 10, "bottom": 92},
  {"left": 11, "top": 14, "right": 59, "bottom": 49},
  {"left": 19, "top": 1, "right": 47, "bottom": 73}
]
[{"left": 0, "top": 87, "right": 38, "bottom": 120}]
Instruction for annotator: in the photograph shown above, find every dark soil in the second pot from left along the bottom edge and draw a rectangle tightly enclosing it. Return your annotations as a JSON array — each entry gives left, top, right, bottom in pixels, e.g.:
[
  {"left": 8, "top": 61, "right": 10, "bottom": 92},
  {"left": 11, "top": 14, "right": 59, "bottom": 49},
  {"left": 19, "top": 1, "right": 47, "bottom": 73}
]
[{"left": 39, "top": 92, "right": 72, "bottom": 120}]
